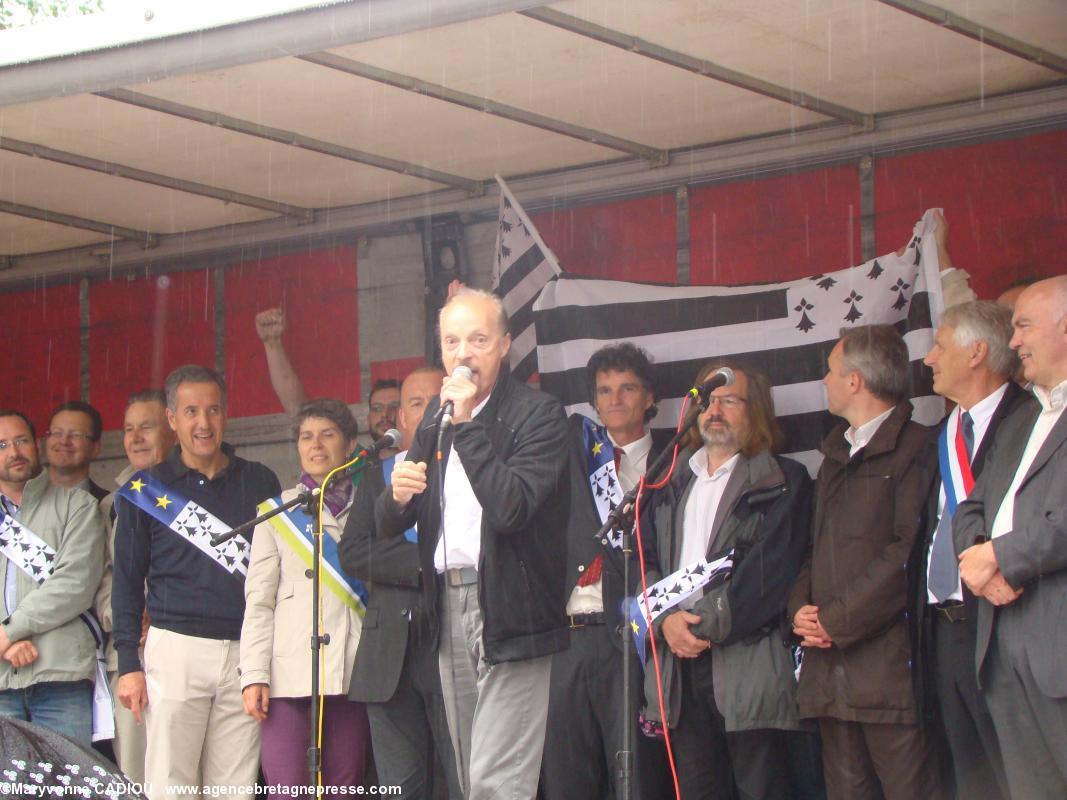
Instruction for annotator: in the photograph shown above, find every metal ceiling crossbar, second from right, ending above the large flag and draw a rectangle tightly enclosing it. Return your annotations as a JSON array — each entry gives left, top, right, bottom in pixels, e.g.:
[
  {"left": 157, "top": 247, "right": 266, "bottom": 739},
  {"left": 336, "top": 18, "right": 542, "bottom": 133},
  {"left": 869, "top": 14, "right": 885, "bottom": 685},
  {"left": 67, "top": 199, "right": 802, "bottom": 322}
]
[{"left": 519, "top": 9, "right": 874, "bottom": 130}]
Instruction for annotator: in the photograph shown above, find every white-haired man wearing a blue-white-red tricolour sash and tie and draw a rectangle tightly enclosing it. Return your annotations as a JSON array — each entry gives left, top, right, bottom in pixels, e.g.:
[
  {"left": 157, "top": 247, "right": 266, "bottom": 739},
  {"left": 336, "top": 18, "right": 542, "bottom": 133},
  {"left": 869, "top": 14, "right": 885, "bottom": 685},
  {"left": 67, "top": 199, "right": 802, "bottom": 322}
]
[{"left": 915, "top": 301, "right": 1033, "bottom": 800}]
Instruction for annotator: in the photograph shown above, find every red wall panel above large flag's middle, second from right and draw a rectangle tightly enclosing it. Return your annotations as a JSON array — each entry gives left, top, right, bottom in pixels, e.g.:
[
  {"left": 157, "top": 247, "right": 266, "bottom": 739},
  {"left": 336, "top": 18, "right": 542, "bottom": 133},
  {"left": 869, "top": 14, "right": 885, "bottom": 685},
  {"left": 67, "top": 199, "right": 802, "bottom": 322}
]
[{"left": 689, "top": 165, "right": 861, "bottom": 285}]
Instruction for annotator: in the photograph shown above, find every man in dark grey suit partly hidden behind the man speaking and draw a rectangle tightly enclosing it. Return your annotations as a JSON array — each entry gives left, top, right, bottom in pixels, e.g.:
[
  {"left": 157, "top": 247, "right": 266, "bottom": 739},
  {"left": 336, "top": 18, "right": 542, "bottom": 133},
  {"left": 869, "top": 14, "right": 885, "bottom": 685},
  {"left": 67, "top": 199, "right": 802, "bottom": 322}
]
[{"left": 340, "top": 367, "right": 462, "bottom": 800}]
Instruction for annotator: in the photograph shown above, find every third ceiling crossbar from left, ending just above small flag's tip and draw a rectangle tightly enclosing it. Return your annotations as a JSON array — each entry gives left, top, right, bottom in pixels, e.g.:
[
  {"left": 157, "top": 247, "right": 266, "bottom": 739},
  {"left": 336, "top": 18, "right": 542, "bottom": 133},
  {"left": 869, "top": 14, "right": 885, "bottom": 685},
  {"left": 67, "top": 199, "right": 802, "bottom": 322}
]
[{"left": 95, "top": 89, "right": 484, "bottom": 195}]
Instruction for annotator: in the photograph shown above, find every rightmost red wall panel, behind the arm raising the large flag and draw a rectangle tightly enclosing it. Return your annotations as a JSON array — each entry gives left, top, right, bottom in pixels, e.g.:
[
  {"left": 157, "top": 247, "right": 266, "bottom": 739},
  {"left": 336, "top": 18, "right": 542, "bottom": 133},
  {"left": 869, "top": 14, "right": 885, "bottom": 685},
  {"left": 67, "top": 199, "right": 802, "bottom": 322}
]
[{"left": 875, "top": 131, "right": 1067, "bottom": 299}]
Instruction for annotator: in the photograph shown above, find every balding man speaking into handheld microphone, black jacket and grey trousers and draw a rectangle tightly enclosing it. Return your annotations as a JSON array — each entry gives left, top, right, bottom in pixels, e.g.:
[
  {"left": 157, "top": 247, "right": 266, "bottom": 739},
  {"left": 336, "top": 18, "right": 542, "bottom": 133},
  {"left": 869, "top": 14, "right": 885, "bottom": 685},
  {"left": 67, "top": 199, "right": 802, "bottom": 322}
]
[{"left": 377, "top": 288, "right": 568, "bottom": 800}]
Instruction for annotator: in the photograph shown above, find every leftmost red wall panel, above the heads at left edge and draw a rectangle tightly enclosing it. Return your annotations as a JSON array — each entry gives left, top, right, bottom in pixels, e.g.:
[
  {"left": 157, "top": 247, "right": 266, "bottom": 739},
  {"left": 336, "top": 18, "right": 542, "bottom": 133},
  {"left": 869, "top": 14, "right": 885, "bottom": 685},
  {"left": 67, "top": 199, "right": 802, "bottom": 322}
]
[{"left": 0, "top": 284, "right": 81, "bottom": 433}]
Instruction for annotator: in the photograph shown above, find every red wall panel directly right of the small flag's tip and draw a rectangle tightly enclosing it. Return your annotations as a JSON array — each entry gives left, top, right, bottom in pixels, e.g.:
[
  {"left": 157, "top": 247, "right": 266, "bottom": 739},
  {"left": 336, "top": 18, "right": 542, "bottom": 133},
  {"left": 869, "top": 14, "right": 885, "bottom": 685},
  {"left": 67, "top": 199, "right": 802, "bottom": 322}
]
[{"left": 530, "top": 194, "right": 676, "bottom": 283}]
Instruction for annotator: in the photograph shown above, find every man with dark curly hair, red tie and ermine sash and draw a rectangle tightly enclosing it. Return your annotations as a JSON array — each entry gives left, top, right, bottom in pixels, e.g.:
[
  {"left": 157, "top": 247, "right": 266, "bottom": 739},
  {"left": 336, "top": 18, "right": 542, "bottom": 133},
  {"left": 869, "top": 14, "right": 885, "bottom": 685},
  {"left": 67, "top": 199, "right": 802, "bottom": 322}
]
[{"left": 541, "top": 342, "right": 667, "bottom": 800}]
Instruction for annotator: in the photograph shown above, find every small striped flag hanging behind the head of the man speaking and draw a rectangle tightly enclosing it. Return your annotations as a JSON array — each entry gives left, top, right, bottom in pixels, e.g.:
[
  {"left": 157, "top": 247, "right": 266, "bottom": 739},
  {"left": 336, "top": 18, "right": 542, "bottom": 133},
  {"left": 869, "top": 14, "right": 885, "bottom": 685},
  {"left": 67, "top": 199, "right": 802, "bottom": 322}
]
[{"left": 493, "top": 175, "right": 562, "bottom": 381}]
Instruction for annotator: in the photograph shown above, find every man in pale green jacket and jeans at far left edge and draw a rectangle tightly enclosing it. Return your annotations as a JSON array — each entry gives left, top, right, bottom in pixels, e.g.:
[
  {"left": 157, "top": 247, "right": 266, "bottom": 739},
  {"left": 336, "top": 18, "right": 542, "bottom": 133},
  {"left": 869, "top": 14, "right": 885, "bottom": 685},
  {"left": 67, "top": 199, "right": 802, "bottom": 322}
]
[{"left": 0, "top": 411, "right": 105, "bottom": 747}]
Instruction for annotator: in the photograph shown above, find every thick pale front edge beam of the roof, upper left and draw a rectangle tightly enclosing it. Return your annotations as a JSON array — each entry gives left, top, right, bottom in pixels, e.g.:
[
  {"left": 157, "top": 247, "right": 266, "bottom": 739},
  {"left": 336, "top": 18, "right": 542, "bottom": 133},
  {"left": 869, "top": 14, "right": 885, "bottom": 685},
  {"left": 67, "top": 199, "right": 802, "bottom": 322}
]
[{"left": 0, "top": 0, "right": 544, "bottom": 106}]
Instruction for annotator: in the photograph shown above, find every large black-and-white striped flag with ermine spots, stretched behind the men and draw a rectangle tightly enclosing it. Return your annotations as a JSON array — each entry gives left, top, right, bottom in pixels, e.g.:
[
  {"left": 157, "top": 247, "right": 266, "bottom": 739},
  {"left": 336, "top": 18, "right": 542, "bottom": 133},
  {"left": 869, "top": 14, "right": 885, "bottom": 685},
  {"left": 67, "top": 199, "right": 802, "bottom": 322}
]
[{"left": 529, "top": 210, "right": 944, "bottom": 468}]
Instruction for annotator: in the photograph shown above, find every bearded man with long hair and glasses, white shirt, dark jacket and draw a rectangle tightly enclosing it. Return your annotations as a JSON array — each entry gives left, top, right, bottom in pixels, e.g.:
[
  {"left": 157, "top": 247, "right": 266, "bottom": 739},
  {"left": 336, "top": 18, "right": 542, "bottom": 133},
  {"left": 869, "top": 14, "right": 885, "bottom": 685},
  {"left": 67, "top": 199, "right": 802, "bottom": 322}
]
[{"left": 641, "top": 363, "right": 811, "bottom": 800}]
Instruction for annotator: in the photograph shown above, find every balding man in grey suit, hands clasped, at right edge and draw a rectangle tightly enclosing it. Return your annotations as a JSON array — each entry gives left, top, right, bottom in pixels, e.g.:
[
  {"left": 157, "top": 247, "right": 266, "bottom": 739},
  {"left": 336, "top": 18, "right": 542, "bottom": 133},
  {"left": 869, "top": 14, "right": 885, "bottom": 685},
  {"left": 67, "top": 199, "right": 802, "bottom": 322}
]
[{"left": 953, "top": 276, "right": 1067, "bottom": 800}]
